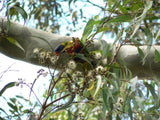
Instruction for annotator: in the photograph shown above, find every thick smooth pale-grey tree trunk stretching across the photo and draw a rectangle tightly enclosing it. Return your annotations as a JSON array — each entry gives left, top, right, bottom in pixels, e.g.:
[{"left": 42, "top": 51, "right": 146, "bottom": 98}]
[{"left": 0, "top": 18, "right": 160, "bottom": 79}]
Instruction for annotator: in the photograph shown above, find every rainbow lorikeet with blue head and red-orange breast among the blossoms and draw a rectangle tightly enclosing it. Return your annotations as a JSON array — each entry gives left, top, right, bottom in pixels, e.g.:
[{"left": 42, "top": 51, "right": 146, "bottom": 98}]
[{"left": 55, "top": 38, "right": 95, "bottom": 70}]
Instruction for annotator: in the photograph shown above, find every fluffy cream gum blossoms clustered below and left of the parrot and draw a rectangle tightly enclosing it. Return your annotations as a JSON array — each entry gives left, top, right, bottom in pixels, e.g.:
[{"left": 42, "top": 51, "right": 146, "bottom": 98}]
[{"left": 33, "top": 44, "right": 107, "bottom": 99}]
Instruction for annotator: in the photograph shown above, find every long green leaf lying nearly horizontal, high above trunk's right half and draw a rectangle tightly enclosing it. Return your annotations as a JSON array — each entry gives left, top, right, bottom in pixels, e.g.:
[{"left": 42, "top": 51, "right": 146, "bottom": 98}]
[{"left": 108, "top": 15, "right": 132, "bottom": 23}]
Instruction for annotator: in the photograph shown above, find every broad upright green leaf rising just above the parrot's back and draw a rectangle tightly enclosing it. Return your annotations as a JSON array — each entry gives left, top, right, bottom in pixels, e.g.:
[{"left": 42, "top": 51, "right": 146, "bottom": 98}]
[{"left": 82, "top": 19, "right": 94, "bottom": 42}]
